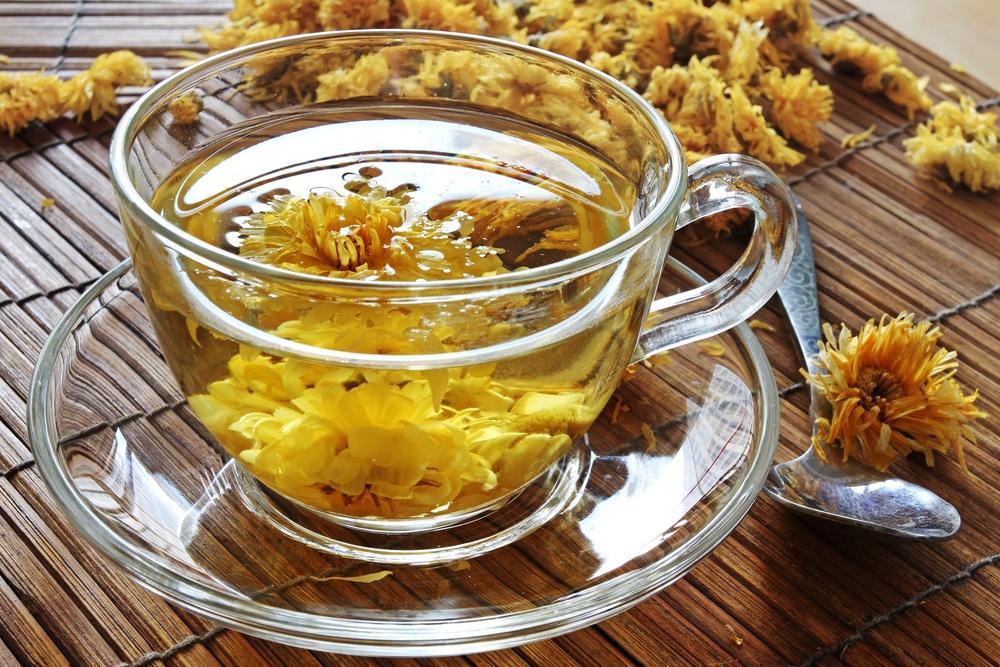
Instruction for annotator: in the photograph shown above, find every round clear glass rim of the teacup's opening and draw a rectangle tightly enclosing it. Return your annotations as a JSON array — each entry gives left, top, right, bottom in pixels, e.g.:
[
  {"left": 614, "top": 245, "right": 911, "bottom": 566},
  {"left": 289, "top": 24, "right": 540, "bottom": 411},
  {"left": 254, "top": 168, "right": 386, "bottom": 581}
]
[{"left": 109, "top": 29, "right": 687, "bottom": 292}]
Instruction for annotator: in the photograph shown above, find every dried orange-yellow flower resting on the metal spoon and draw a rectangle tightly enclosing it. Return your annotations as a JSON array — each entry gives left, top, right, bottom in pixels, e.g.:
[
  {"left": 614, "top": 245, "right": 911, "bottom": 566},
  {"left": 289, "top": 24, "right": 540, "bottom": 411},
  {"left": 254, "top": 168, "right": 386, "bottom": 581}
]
[{"left": 803, "top": 313, "right": 987, "bottom": 471}]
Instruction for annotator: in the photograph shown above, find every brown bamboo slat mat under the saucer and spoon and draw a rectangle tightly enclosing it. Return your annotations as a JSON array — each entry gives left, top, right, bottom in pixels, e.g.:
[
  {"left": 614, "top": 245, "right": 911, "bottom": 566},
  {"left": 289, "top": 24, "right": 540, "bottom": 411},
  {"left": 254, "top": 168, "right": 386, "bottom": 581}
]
[{"left": 0, "top": 0, "right": 1000, "bottom": 667}]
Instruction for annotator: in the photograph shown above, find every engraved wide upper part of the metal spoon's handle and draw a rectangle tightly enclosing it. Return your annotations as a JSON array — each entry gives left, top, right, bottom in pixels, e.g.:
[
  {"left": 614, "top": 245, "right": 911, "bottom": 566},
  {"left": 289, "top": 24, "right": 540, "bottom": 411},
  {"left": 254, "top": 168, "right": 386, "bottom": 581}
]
[{"left": 778, "top": 193, "right": 823, "bottom": 371}]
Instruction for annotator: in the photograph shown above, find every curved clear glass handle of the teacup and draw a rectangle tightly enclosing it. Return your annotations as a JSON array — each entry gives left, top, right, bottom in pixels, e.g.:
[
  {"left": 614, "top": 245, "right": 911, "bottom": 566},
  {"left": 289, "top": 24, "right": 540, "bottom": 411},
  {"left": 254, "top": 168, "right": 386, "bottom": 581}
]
[{"left": 632, "top": 154, "right": 796, "bottom": 363}]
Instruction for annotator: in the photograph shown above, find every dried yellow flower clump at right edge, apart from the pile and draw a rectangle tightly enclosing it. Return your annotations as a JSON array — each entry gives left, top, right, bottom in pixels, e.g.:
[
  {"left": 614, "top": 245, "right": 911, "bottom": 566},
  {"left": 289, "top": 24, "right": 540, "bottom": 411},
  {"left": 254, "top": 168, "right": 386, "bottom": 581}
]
[{"left": 903, "top": 95, "right": 1000, "bottom": 192}]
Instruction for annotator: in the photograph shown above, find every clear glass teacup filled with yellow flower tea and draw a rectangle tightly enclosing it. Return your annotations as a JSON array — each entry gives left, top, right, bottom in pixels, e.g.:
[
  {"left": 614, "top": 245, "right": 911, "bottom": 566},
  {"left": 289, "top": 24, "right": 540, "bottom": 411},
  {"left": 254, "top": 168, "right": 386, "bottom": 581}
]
[{"left": 111, "top": 31, "right": 795, "bottom": 533}]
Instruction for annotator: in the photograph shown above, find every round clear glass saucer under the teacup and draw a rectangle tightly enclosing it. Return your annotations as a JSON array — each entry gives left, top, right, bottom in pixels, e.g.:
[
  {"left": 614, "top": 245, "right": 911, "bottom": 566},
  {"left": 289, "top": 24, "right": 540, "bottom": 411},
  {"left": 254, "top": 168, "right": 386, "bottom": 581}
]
[{"left": 28, "top": 260, "right": 778, "bottom": 656}]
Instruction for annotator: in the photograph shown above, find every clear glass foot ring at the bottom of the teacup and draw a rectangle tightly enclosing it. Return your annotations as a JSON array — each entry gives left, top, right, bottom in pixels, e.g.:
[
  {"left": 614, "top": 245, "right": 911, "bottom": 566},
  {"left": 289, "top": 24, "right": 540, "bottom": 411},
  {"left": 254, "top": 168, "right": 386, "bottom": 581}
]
[{"left": 224, "top": 436, "right": 591, "bottom": 566}]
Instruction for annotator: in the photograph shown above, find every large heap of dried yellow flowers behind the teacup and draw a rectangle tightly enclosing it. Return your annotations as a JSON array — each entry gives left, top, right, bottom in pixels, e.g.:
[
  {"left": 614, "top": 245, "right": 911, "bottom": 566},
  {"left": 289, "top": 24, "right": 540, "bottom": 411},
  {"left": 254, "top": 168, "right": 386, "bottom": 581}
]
[{"left": 201, "top": 0, "right": 844, "bottom": 172}]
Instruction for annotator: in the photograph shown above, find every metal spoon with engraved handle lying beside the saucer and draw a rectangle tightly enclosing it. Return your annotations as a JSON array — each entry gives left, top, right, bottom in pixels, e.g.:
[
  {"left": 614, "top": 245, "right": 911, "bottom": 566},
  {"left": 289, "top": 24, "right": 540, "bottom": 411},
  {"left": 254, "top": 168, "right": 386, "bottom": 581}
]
[{"left": 764, "top": 195, "right": 962, "bottom": 540}]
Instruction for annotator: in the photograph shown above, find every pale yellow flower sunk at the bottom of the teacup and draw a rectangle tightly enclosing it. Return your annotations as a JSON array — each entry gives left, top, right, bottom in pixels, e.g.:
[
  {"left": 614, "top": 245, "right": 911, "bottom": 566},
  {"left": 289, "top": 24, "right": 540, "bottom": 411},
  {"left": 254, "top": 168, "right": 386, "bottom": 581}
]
[{"left": 230, "top": 380, "right": 497, "bottom": 508}]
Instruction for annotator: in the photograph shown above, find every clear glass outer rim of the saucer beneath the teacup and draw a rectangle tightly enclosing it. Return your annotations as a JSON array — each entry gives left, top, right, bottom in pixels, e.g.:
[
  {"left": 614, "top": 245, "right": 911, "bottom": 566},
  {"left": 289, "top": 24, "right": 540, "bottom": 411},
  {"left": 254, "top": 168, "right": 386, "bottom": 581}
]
[{"left": 27, "top": 260, "right": 779, "bottom": 657}]
